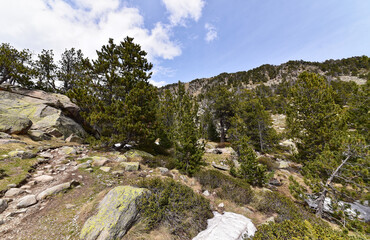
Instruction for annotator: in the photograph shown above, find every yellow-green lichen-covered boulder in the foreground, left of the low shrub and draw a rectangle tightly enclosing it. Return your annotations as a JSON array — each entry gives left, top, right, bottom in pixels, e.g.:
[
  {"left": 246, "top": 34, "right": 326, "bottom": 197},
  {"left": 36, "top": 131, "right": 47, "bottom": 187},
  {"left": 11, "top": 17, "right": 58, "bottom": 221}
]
[{"left": 80, "top": 186, "right": 149, "bottom": 240}]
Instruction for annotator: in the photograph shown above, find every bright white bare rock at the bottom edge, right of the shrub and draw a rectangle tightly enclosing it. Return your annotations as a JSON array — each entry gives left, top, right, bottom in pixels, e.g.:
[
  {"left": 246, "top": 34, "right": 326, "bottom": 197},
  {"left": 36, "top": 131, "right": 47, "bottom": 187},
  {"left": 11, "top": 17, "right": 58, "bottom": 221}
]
[{"left": 193, "top": 212, "right": 257, "bottom": 240}]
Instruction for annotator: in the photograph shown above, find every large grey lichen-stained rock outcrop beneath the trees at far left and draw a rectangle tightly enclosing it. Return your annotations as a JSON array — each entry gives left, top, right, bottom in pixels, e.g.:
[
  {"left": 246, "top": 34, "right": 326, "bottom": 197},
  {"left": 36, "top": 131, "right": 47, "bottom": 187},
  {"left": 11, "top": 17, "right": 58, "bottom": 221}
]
[{"left": 0, "top": 86, "right": 86, "bottom": 140}]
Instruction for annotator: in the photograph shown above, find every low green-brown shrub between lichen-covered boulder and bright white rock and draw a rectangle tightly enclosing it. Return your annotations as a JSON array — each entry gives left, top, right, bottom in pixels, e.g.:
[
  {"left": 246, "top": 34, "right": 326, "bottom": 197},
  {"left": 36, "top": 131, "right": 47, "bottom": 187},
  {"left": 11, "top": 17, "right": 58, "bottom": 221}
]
[{"left": 138, "top": 178, "right": 213, "bottom": 239}]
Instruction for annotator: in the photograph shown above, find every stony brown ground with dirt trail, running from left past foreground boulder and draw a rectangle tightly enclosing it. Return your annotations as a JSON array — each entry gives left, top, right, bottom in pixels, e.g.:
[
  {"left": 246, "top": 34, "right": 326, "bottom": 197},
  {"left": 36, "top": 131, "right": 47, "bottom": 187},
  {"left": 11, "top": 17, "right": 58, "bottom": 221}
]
[{"left": 0, "top": 131, "right": 304, "bottom": 239}]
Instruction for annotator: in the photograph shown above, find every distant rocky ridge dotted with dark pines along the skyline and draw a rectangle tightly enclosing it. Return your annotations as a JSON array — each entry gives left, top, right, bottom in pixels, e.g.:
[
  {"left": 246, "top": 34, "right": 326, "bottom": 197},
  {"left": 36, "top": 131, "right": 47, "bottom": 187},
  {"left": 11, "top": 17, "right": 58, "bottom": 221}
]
[{"left": 162, "top": 56, "right": 370, "bottom": 96}]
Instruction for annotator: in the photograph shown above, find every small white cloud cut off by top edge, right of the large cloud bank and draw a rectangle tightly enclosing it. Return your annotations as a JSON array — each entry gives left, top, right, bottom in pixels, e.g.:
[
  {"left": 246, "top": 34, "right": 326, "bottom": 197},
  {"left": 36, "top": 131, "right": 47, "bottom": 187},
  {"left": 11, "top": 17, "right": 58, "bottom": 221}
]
[{"left": 162, "top": 0, "right": 205, "bottom": 25}]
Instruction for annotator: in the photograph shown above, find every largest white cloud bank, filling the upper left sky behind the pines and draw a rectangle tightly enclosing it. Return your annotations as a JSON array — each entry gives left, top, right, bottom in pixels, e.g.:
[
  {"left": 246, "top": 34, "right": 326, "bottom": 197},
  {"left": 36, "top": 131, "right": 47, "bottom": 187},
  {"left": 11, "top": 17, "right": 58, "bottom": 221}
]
[{"left": 0, "top": 0, "right": 181, "bottom": 62}]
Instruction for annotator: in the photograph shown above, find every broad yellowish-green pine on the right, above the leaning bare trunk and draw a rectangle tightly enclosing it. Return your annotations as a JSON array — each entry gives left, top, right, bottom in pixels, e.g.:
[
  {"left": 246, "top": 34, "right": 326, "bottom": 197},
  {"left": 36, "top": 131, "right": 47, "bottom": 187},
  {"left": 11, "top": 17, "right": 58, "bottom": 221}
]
[{"left": 287, "top": 72, "right": 345, "bottom": 162}]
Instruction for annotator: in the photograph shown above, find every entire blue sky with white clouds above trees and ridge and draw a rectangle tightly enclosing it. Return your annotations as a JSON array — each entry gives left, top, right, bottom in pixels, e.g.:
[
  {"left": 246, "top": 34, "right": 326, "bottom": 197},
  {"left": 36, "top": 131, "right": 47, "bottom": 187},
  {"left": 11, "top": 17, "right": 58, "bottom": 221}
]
[{"left": 0, "top": 0, "right": 370, "bottom": 85}]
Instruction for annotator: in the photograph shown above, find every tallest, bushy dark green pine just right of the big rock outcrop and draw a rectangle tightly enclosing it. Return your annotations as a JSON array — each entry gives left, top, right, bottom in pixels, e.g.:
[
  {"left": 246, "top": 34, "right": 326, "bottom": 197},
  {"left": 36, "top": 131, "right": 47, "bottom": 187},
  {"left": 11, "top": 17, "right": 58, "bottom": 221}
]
[{"left": 70, "top": 37, "right": 157, "bottom": 145}]
